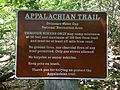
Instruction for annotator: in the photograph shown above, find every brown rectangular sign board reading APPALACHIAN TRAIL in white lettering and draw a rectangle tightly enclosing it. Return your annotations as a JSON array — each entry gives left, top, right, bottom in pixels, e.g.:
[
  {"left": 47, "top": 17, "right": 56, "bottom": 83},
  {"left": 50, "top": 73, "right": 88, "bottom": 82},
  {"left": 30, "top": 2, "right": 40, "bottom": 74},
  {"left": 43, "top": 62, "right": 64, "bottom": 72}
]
[{"left": 16, "top": 11, "right": 107, "bottom": 79}]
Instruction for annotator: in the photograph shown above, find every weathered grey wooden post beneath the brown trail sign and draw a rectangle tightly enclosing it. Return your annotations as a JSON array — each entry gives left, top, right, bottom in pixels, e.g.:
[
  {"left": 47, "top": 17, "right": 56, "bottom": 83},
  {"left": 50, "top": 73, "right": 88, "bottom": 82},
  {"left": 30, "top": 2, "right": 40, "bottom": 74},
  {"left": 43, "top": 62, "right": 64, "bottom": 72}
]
[{"left": 44, "top": 80, "right": 78, "bottom": 90}]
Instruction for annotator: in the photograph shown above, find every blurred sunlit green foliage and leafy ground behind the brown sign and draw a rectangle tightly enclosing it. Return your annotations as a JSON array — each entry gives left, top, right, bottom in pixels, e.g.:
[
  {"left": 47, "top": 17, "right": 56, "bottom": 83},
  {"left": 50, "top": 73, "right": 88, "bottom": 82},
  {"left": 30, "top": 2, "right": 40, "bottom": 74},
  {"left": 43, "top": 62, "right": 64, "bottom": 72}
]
[{"left": 0, "top": 0, "right": 120, "bottom": 90}]
